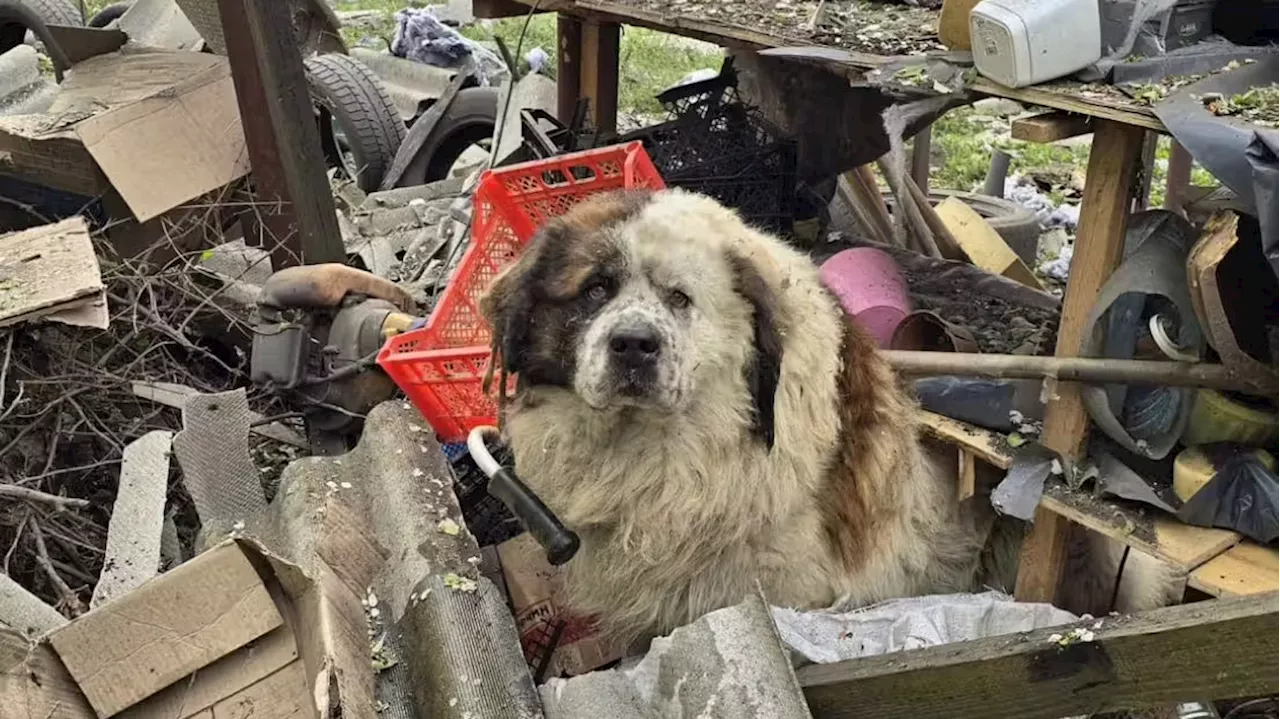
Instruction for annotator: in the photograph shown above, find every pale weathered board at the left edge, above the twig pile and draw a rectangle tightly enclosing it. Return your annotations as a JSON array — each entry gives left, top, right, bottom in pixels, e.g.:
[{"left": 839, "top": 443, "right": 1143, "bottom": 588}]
[{"left": 0, "top": 216, "right": 108, "bottom": 329}]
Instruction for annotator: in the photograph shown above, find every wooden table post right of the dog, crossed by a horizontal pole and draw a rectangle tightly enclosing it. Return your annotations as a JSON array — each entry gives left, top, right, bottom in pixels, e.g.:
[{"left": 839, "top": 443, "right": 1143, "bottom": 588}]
[{"left": 1014, "top": 120, "right": 1146, "bottom": 603}]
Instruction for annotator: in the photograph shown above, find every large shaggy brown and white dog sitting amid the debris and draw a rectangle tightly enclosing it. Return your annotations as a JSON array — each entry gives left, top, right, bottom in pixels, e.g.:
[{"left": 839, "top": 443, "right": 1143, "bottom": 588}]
[{"left": 483, "top": 191, "right": 1177, "bottom": 637}]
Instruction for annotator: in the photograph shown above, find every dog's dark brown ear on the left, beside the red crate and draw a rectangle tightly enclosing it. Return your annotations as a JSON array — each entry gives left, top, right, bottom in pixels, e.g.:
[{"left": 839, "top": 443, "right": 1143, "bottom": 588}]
[{"left": 480, "top": 230, "right": 545, "bottom": 374}]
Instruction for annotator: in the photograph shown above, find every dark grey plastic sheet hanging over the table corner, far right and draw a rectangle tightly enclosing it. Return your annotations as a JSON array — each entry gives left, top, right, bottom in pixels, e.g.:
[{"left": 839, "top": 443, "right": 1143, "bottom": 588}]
[{"left": 1153, "top": 52, "right": 1280, "bottom": 276}]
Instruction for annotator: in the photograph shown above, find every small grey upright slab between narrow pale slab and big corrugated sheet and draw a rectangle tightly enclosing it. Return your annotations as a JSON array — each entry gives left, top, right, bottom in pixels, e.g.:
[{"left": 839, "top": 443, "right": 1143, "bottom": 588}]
[{"left": 173, "top": 388, "right": 266, "bottom": 526}]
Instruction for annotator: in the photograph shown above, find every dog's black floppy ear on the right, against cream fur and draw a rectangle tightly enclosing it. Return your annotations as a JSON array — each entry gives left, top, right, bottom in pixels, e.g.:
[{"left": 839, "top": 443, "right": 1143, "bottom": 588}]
[{"left": 728, "top": 252, "right": 782, "bottom": 450}]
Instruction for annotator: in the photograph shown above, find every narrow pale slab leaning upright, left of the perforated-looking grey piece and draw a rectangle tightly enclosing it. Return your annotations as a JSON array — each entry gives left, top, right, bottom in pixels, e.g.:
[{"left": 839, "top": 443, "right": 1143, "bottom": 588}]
[{"left": 90, "top": 430, "right": 173, "bottom": 608}]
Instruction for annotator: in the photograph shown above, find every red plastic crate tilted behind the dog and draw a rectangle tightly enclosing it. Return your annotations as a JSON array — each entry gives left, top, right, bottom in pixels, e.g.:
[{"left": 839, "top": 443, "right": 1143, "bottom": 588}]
[{"left": 378, "top": 142, "right": 666, "bottom": 441}]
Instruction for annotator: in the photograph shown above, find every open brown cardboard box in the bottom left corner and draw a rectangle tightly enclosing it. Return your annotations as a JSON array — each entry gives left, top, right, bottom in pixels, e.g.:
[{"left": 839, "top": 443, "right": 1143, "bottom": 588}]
[{"left": 31, "top": 532, "right": 380, "bottom": 719}]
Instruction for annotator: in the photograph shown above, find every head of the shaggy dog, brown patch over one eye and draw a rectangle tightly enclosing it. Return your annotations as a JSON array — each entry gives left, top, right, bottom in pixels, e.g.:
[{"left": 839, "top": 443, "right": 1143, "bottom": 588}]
[{"left": 481, "top": 191, "right": 782, "bottom": 445}]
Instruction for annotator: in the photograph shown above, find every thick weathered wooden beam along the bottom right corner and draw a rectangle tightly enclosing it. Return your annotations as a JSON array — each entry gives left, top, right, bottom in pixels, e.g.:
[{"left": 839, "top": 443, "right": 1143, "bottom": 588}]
[{"left": 796, "top": 594, "right": 1280, "bottom": 719}]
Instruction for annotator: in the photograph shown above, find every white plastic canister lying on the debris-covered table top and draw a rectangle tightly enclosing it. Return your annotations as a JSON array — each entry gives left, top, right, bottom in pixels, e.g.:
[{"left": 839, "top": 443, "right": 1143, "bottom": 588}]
[{"left": 969, "top": 0, "right": 1102, "bottom": 87}]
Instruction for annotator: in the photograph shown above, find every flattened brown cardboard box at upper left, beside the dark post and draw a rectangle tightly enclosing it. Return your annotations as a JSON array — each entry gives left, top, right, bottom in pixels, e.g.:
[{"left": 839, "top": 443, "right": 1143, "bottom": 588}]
[{"left": 0, "top": 50, "right": 250, "bottom": 221}]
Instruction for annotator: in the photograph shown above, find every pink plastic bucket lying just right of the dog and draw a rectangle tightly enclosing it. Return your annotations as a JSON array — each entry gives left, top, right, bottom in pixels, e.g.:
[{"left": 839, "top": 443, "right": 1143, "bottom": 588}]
[{"left": 818, "top": 247, "right": 911, "bottom": 348}]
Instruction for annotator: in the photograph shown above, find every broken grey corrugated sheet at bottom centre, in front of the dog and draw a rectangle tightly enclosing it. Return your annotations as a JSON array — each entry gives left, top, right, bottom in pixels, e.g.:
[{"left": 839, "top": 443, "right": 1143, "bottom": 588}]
[{"left": 540, "top": 595, "right": 812, "bottom": 719}]
